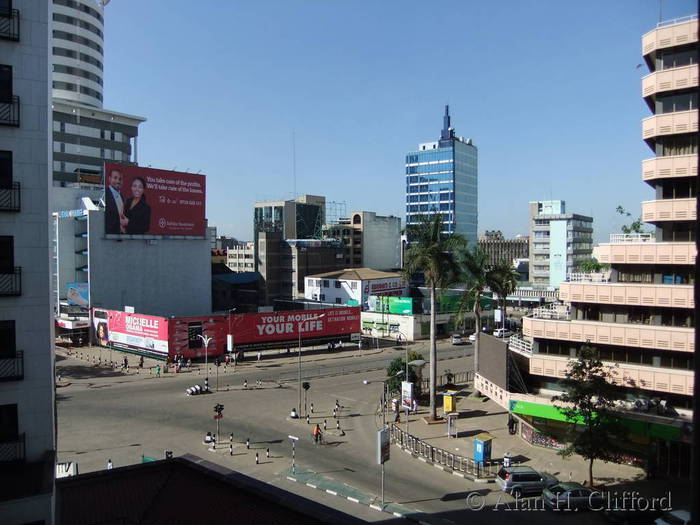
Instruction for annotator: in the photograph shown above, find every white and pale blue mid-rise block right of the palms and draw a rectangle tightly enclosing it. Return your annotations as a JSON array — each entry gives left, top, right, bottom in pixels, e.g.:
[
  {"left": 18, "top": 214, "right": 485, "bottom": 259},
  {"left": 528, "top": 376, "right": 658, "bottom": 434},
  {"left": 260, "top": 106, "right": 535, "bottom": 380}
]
[{"left": 528, "top": 200, "right": 593, "bottom": 287}]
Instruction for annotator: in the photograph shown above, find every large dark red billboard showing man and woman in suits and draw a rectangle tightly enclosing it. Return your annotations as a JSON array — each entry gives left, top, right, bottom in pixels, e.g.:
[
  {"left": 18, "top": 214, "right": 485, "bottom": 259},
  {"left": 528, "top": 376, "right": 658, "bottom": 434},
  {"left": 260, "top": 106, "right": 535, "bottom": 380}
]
[{"left": 105, "top": 162, "right": 206, "bottom": 237}]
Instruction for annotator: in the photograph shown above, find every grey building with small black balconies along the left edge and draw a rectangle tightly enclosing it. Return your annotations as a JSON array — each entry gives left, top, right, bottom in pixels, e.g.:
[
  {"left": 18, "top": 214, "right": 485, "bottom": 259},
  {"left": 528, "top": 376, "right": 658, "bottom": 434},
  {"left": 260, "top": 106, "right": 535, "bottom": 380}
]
[{"left": 0, "top": 0, "right": 56, "bottom": 524}]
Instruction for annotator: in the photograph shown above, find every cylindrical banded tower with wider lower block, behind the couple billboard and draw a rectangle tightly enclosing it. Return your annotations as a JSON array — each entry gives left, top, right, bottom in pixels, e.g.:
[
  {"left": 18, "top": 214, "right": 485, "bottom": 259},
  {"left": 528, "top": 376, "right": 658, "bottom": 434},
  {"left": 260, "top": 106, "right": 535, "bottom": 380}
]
[{"left": 51, "top": 0, "right": 146, "bottom": 199}]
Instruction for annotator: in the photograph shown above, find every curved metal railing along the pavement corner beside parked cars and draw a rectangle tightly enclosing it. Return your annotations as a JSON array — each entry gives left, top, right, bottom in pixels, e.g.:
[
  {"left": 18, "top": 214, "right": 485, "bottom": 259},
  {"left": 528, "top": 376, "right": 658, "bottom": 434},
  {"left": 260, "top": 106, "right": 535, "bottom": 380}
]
[{"left": 390, "top": 424, "right": 499, "bottom": 479}]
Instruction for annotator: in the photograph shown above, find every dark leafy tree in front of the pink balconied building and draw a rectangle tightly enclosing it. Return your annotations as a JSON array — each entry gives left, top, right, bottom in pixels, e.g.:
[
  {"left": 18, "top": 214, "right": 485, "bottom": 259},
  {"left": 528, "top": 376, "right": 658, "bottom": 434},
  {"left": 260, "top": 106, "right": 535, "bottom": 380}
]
[{"left": 552, "top": 343, "right": 626, "bottom": 486}]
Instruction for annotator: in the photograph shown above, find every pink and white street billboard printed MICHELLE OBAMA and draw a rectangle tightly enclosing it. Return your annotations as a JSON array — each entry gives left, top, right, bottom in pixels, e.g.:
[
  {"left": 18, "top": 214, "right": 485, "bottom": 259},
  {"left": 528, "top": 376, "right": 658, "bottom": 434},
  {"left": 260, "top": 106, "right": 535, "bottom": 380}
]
[{"left": 92, "top": 308, "right": 168, "bottom": 355}]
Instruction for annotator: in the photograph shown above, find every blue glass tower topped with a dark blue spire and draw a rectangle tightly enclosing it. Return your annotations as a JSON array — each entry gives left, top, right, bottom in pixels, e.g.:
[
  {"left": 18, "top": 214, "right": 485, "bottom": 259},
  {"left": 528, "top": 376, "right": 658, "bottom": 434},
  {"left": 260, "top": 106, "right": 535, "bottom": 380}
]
[{"left": 406, "top": 106, "right": 478, "bottom": 245}]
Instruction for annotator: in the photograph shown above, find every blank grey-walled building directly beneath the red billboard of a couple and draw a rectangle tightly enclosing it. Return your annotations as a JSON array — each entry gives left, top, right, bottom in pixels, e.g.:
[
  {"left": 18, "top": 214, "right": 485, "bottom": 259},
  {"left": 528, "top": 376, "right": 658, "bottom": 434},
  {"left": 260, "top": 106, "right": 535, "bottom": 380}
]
[{"left": 54, "top": 209, "right": 212, "bottom": 316}]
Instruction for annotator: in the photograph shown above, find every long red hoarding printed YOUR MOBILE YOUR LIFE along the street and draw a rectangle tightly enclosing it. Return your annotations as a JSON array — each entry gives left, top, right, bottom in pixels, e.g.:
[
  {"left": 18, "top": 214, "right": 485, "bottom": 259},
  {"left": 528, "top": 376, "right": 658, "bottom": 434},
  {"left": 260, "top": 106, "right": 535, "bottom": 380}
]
[{"left": 231, "top": 306, "right": 360, "bottom": 346}]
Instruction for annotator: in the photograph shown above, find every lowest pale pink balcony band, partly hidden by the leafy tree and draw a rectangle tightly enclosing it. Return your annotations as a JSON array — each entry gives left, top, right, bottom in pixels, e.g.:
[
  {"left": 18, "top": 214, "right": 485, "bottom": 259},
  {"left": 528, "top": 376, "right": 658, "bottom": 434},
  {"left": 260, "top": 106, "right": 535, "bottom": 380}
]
[{"left": 530, "top": 354, "right": 693, "bottom": 396}]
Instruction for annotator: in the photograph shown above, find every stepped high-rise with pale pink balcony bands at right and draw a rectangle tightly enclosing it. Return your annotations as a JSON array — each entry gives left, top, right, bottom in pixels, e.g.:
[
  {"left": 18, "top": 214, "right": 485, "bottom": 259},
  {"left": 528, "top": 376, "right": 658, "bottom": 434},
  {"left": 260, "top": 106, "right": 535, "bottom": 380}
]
[{"left": 506, "top": 15, "right": 698, "bottom": 477}]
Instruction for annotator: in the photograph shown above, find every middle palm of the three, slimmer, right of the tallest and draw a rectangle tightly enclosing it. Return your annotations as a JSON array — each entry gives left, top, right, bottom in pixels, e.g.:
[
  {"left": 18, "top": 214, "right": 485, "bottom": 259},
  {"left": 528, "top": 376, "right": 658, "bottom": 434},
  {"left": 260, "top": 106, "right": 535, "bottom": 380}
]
[{"left": 459, "top": 246, "right": 493, "bottom": 394}]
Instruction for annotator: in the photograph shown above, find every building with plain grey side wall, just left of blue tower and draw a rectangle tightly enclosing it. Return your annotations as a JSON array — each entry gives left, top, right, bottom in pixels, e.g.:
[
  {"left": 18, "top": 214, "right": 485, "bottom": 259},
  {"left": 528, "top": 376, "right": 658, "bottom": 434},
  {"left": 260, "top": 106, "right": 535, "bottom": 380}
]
[{"left": 323, "top": 211, "right": 401, "bottom": 270}]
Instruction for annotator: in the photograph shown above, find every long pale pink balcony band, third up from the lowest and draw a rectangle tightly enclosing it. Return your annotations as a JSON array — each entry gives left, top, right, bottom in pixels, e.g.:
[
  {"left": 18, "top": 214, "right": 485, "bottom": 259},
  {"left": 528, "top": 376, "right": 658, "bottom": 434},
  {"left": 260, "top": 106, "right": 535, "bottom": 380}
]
[{"left": 559, "top": 283, "right": 695, "bottom": 308}]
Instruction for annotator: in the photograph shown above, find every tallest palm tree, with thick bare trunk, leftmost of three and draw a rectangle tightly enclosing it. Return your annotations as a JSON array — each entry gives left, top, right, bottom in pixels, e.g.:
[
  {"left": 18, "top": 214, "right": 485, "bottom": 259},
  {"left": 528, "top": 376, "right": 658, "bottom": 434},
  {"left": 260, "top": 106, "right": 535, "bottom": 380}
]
[{"left": 401, "top": 213, "right": 467, "bottom": 419}]
